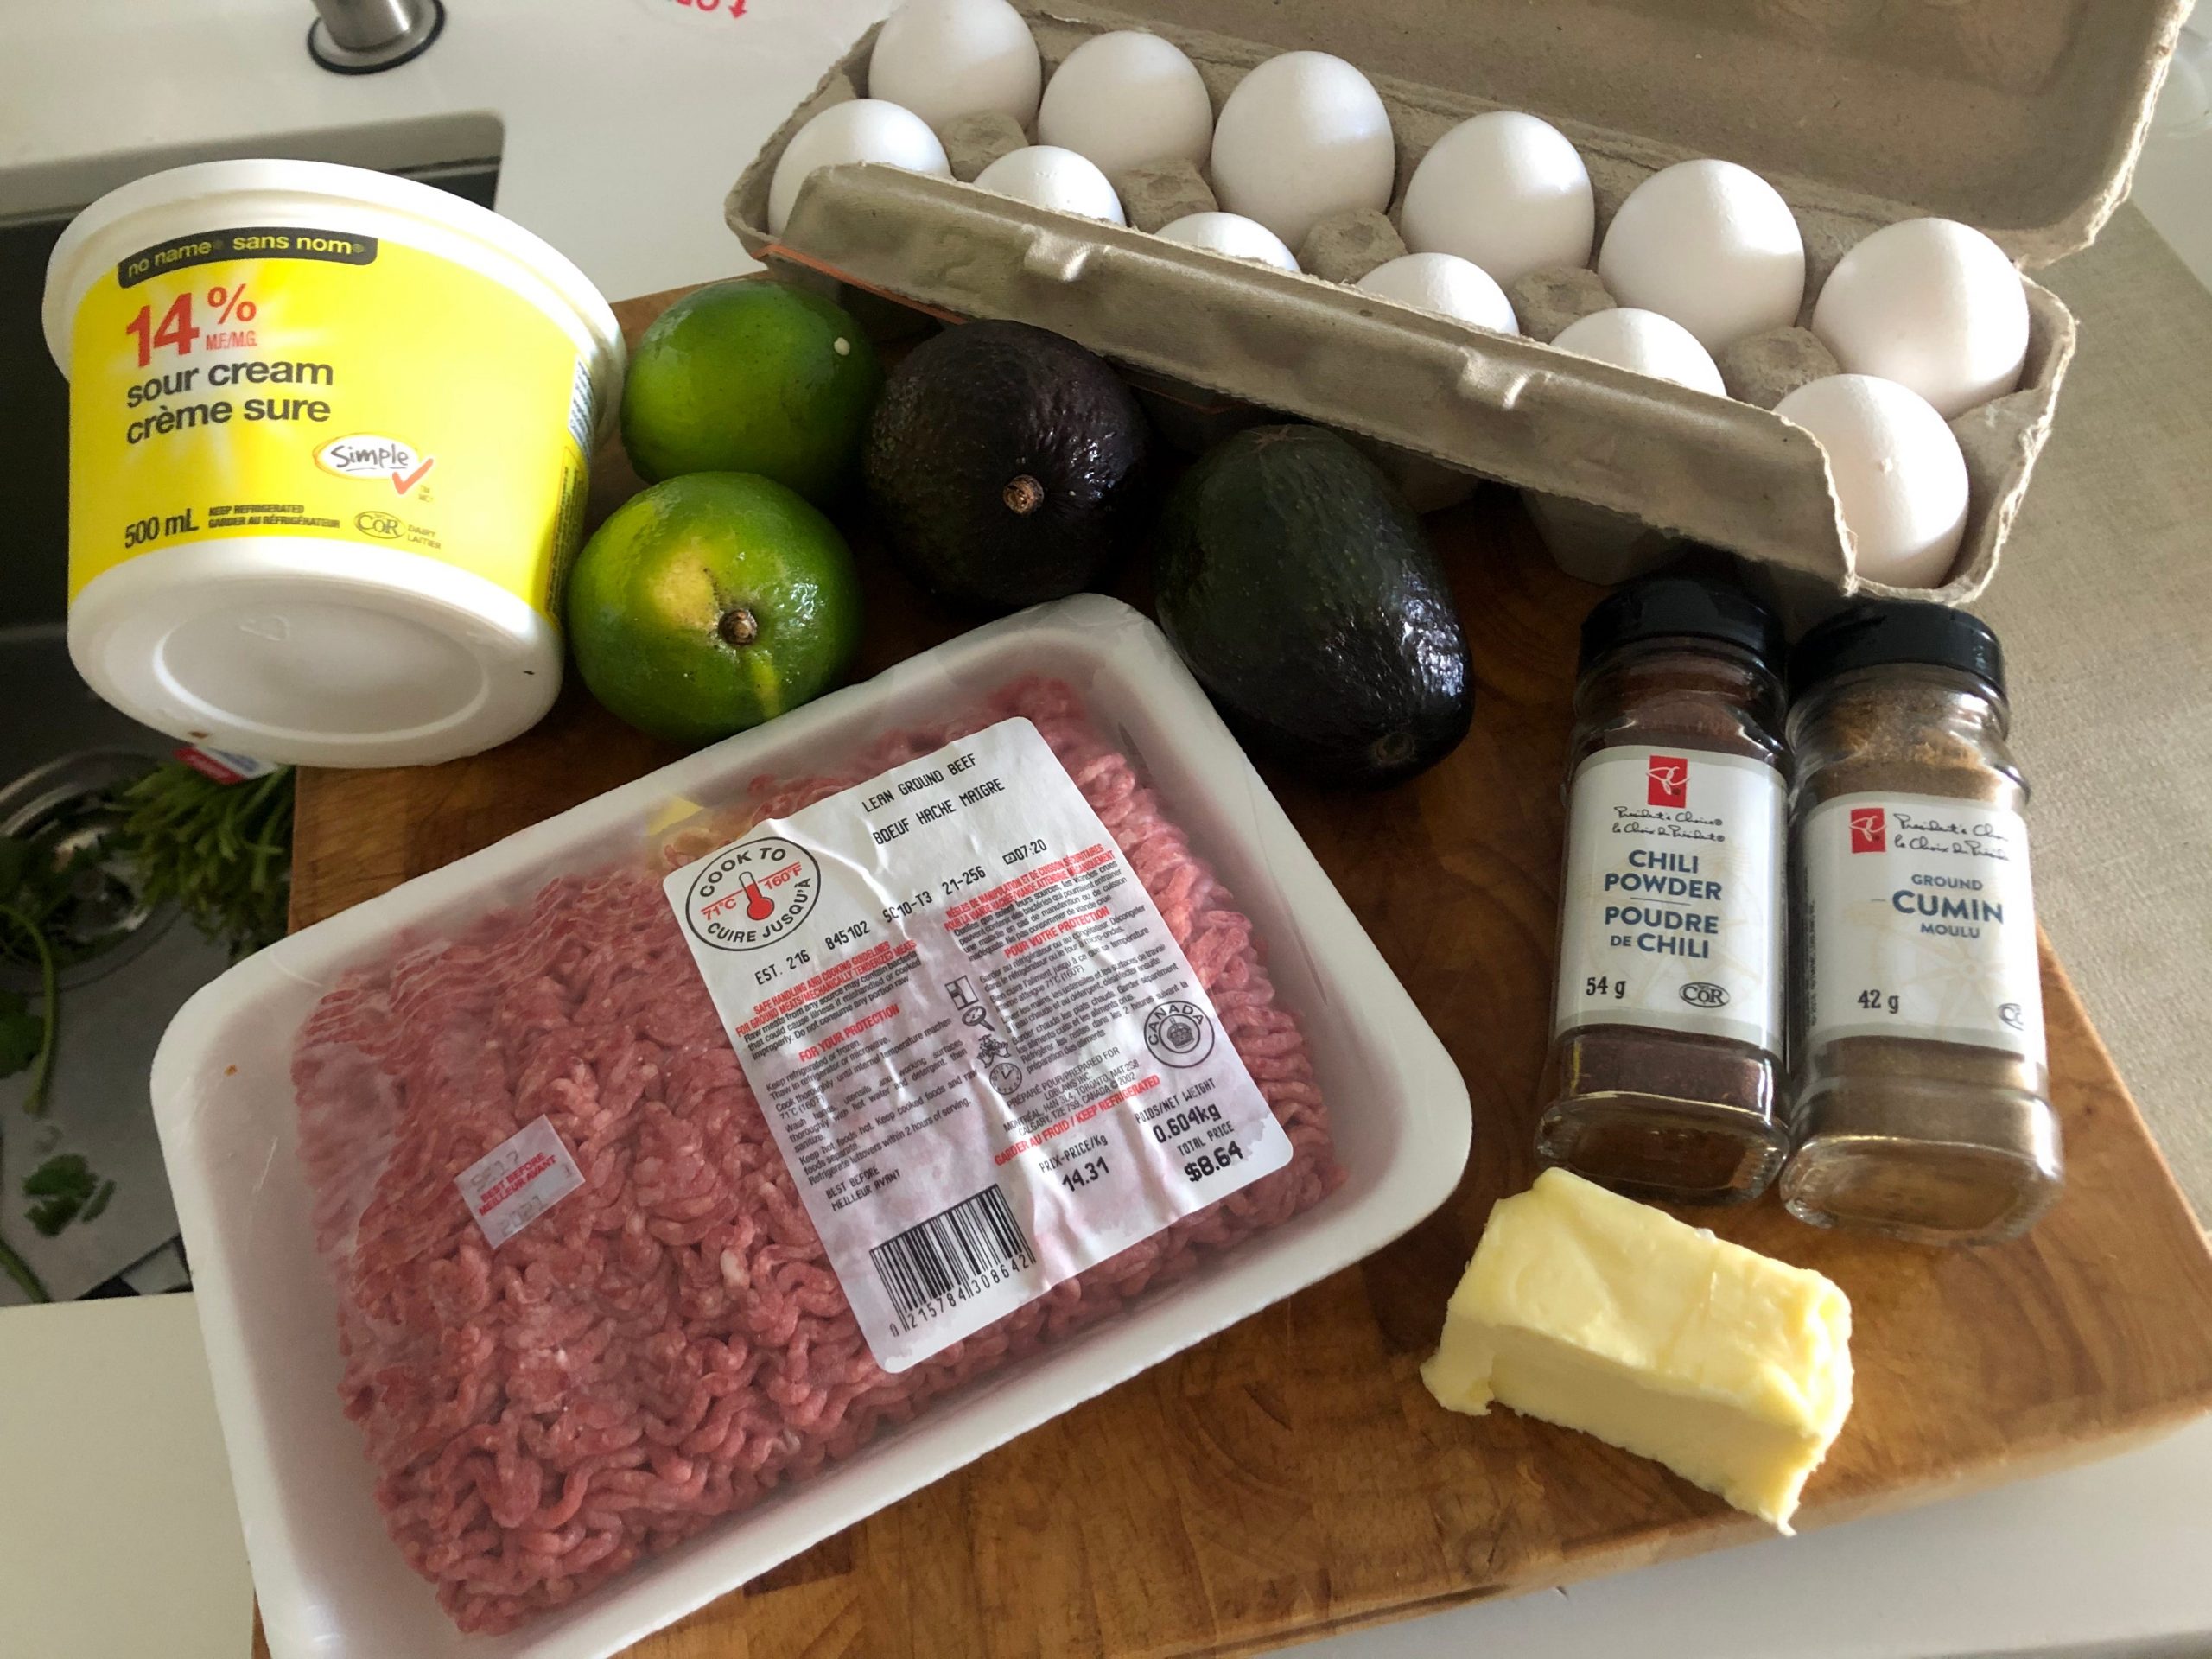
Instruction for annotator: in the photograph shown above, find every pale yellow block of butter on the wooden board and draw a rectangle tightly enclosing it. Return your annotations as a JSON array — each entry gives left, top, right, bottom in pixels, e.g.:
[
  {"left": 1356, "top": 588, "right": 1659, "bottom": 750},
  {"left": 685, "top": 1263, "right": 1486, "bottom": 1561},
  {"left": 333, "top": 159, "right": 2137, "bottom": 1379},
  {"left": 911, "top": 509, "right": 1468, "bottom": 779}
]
[{"left": 1421, "top": 1170, "right": 1852, "bottom": 1533}]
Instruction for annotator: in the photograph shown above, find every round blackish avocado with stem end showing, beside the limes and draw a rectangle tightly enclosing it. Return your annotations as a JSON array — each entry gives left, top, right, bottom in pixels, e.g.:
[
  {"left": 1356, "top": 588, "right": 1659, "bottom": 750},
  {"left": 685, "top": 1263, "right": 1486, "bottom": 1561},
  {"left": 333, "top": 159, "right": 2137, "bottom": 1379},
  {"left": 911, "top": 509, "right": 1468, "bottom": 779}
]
[{"left": 861, "top": 323, "right": 1150, "bottom": 611}]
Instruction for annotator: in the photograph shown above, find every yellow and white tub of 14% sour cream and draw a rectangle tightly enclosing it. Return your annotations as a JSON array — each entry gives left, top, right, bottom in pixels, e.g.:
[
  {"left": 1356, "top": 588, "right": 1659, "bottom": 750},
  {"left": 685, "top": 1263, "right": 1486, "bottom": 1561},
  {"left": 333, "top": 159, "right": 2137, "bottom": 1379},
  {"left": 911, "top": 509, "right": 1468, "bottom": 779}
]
[{"left": 44, "top": 162, "right": 624, "bottom": 766}]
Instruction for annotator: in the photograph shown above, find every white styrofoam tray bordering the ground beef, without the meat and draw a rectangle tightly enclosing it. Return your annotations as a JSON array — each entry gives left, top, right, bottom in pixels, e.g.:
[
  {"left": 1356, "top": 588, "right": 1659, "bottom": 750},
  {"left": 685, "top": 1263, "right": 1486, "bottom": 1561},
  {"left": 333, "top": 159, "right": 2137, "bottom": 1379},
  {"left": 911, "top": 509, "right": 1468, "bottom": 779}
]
[{"left": 153, "top": 595, "right": 1469, "bottom": 1659}]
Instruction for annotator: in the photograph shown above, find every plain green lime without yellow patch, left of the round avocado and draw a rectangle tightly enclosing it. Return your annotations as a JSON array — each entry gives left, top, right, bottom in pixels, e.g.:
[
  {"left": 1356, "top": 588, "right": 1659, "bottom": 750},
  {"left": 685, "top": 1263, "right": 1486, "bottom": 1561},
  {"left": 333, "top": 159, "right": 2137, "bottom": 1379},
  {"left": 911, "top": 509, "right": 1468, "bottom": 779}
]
[{"left": 621, "top": 276, "right": 882, "bottom": 502}]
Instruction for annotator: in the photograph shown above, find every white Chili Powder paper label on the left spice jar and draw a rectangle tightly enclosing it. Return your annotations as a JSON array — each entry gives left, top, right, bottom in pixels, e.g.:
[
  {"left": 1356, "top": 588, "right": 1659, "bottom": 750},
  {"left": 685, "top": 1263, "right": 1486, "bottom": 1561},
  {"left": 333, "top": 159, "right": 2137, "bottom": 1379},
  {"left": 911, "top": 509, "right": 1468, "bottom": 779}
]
[{"left": 1553, "top": 747, "right": 1783, "bottom": 1053}]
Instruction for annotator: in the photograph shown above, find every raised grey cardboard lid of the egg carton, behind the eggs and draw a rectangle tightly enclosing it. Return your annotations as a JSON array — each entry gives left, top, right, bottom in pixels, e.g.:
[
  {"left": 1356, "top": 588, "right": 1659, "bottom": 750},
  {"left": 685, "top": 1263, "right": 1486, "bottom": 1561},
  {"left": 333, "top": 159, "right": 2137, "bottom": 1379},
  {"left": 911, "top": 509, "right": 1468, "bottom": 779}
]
[{"left": 1088, "top": 0, "right": 2188, "bottom": 270}]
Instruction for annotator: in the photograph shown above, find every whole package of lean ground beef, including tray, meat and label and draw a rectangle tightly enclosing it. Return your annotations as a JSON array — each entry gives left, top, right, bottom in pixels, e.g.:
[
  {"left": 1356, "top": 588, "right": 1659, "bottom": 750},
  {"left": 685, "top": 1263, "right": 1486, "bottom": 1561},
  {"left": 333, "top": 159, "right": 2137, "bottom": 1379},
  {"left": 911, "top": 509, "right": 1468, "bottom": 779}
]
[{"left": 157, "top": 597, "right": 1466, "bottom": 1655}]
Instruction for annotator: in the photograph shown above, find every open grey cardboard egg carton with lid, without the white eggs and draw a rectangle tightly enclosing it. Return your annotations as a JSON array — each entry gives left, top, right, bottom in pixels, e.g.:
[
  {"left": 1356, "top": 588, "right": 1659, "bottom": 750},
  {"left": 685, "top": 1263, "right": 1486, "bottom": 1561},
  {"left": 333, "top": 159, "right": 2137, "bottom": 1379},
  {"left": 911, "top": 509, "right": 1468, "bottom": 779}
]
[{"left": 726, "top": 0, "right": 2188, "bottom": 604}]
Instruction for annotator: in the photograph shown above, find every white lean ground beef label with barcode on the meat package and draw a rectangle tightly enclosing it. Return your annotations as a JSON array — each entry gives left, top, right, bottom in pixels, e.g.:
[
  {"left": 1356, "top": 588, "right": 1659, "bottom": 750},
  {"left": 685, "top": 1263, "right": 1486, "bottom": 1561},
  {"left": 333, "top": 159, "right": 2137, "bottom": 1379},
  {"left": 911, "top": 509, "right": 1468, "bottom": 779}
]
[{"left": 666, "top": 719, "right": 1289, "bottom": 1371}]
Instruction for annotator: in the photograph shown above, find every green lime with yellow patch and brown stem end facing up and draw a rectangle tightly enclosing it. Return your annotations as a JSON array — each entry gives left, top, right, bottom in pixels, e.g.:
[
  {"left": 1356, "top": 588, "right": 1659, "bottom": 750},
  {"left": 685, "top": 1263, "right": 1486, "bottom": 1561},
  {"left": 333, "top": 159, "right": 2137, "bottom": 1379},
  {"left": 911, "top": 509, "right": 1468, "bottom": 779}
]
[{"left": 569, "top": 474, "right": 861, "bottom": 743}]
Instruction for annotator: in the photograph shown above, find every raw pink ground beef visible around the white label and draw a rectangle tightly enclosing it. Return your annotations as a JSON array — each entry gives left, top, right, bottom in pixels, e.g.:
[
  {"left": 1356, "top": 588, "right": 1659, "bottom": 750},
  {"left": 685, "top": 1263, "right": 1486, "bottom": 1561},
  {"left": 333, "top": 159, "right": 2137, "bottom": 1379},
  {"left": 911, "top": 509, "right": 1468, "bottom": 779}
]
[{"left": 292, "top": 681, "right": 1343, "bottom": 1630}]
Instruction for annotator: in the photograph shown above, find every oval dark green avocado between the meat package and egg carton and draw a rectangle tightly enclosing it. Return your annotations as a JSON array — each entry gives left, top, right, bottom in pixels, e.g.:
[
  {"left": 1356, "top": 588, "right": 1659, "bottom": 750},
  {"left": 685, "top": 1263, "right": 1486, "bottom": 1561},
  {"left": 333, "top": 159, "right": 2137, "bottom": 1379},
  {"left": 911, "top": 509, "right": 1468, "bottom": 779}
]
[{"left": 1153, "top": 427, "right": 1473, "bottom": 787}]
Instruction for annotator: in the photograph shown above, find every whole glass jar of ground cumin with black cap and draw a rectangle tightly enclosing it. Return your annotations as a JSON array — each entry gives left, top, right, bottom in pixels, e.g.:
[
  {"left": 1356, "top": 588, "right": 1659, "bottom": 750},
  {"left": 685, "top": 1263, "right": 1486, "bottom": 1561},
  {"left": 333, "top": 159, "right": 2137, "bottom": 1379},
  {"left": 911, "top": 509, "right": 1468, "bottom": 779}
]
[{"left": 1783, "top": 600, "right": 2063, "bottom": 1243}]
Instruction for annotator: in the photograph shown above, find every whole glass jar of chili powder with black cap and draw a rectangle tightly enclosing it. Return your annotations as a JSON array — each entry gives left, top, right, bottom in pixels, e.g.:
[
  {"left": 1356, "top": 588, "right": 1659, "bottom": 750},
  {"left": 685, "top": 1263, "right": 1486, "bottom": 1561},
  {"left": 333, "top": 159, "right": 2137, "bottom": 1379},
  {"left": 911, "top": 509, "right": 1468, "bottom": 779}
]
[{"left": 1537, "top": 575, "right": 1789, "bottom": 1204}]
